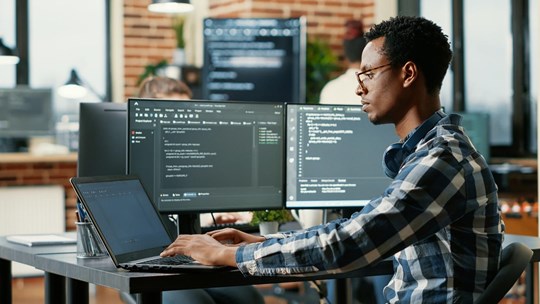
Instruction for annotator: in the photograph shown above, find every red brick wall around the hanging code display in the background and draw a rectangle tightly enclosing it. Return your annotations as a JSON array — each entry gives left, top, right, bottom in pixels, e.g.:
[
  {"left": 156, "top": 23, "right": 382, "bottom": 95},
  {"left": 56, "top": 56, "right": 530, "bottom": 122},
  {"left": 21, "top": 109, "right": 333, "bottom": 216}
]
[{"left": 124, "top": 0, "right": 375, "bottom": 97}]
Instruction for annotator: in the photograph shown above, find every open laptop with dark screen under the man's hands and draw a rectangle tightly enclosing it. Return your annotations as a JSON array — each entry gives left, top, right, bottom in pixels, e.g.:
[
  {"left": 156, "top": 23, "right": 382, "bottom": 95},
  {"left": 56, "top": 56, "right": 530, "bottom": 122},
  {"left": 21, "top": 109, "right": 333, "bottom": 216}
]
[{"left": 70, "top": 175, "right": 230, "bottom": 272}]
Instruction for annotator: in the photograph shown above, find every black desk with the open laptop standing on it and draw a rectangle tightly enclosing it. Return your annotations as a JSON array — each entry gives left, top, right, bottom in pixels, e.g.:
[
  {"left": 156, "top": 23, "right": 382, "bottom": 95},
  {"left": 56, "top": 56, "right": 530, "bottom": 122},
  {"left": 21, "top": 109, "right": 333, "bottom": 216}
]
[{"left": 0, "top": 235, "right": 540, "bottom": 303}]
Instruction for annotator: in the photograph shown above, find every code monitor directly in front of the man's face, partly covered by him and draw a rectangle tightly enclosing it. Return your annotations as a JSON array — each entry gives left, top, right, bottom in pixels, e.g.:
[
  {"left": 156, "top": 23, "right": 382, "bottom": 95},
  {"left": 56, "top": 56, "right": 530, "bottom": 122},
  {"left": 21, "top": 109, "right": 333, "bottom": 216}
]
[{"left": 285, "top": 104, "right": 398, "bottom": 209}]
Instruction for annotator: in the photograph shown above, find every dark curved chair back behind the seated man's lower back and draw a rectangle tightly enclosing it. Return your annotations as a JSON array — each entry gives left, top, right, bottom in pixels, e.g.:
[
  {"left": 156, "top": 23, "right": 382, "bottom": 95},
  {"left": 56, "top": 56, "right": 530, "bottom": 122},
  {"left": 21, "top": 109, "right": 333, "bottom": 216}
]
[{"left": 475, "top": 243, "right": 533, "bottom": 304}]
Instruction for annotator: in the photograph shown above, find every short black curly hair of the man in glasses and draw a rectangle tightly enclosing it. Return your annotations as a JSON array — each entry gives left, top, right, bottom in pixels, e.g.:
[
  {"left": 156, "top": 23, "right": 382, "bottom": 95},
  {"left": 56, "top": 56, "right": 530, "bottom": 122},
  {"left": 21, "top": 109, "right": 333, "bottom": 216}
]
[{"left": 364, "top": 16, "right": 452, "bottom": 94}]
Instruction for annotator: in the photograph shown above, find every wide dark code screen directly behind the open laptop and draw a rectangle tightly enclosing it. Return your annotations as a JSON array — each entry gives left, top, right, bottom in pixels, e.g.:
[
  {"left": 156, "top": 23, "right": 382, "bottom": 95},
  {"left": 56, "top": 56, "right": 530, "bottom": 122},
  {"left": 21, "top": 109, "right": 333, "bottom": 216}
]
[{"left": 128, "top": 98, "right": 284, "bottom": 214}]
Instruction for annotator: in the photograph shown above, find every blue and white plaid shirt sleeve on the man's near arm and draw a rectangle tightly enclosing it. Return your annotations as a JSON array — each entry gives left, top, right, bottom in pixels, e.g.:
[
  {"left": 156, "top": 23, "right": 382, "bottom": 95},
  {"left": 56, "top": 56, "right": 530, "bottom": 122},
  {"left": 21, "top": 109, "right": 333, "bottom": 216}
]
[{"left": 236, "top": 137, "right": 482, "bottom": 275}]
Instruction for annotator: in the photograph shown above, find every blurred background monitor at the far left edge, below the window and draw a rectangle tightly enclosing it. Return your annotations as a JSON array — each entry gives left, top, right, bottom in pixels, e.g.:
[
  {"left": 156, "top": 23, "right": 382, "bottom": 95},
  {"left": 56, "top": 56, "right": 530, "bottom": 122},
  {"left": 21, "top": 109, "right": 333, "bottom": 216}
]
[{"left": 0, "top": 86, "right": 54, "bottom": 137}]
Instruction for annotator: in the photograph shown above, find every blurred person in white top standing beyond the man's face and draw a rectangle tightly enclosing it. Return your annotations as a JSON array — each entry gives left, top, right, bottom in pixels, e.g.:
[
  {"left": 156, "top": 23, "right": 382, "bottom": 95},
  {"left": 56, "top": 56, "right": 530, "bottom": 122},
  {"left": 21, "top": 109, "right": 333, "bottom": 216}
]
[{"left": 319, "top": 20, "right": 367, "bottom": 104}]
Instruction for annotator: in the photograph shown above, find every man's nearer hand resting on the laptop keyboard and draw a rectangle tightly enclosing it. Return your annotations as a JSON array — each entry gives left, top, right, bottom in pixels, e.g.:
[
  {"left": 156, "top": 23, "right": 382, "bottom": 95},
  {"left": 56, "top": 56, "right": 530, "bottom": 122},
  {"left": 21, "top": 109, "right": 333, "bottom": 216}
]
[{"left": 160, "top": 234, "right": 237, "bottom": 267}]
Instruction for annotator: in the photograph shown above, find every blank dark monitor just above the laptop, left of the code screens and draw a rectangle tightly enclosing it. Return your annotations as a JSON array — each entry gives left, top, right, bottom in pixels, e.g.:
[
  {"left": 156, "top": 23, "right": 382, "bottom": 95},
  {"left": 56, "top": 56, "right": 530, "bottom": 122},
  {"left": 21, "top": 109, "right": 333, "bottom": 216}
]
[{"left": 77, "top": 102, "right": 127, "bottom": 177}]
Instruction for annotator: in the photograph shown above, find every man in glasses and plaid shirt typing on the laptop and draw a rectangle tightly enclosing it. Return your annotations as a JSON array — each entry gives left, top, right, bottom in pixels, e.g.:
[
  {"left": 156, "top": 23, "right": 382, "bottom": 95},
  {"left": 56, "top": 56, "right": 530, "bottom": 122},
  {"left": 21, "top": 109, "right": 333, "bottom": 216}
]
[{"left": 161, "top": 16, "right": 504, "bottom": 303}]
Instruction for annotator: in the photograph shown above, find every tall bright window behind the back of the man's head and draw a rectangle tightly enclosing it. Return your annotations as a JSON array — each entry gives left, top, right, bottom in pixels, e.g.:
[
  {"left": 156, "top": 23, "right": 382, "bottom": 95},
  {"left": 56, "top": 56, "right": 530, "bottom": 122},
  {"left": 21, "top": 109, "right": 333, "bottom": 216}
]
[{"left": 412, "top": 0, "right": 540, "bottom": 157}]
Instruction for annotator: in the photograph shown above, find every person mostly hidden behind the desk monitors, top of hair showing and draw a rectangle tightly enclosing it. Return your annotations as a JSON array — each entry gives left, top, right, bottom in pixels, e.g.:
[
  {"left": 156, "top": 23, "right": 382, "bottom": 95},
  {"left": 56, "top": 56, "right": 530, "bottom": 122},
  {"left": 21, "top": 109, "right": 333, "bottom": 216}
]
[{"left": 122, "top": 77, "right": 264, "bottom": 304}]
